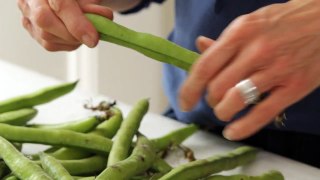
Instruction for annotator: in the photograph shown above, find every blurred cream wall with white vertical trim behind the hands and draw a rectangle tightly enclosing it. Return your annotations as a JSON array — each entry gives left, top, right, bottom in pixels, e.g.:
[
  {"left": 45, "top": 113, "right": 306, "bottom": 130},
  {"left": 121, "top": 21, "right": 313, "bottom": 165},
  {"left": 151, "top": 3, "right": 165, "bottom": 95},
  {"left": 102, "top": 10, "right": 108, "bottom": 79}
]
[{"left": 0, "top": 0, "right": 174, "bottom": 113}]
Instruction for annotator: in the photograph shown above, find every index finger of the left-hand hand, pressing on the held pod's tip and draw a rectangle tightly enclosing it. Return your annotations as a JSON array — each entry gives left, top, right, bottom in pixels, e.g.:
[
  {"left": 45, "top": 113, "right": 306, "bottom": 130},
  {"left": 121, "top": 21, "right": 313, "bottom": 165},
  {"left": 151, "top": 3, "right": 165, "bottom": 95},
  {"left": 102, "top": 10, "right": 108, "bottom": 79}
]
[{"left": 49, "top": 0, "right": 98, "bottom": 47}]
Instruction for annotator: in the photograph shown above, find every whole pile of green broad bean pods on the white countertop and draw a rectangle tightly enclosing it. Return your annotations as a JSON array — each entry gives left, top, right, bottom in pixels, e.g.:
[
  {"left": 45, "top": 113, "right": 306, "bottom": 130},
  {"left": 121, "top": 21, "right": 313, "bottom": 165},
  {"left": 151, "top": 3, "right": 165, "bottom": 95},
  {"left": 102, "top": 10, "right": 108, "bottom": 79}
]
[{"left": 0, "top": 82, "right": 284, "bottom": 180}]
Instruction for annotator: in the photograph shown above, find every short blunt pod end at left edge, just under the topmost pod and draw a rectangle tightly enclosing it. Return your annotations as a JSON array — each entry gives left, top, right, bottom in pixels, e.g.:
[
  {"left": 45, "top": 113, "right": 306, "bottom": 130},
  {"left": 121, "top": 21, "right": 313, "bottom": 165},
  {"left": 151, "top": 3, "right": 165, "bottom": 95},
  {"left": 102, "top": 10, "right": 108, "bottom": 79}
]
[{"left": 0, "top": 108, "right": 38, "bottom": 126}]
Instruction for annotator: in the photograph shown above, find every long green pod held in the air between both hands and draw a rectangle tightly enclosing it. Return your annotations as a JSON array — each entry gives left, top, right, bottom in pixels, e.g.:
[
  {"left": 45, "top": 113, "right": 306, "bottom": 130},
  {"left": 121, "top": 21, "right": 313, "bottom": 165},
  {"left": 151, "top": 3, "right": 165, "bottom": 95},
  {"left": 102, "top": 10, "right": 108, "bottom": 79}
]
[{"left": 86, "top": 14, "right": 199, "bottom": 70}]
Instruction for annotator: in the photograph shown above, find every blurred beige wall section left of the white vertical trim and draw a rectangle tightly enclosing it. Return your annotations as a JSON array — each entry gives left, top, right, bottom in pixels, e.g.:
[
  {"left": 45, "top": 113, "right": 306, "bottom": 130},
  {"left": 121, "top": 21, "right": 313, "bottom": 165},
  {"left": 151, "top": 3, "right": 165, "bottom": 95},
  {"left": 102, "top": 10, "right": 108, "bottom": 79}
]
[{"left": 0, "top": 0, "right": 66, "bottom": 79}]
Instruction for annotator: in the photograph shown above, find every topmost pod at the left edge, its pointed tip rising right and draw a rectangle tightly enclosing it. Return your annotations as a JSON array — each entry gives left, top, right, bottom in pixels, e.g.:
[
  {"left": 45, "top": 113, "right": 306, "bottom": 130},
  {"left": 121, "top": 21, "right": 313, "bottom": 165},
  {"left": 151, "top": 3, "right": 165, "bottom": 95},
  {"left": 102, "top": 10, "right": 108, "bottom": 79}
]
[{"left": 0, "top": 81, "right": 78, "bottom": 113}]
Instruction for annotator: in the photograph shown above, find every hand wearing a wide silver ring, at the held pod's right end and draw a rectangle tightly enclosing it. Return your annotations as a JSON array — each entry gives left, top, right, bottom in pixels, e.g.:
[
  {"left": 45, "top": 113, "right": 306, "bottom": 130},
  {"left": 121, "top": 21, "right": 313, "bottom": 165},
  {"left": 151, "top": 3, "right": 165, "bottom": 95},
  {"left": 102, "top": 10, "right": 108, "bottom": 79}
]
[{"left": 179, "top": 0, "right": 320, "bottom": 140}]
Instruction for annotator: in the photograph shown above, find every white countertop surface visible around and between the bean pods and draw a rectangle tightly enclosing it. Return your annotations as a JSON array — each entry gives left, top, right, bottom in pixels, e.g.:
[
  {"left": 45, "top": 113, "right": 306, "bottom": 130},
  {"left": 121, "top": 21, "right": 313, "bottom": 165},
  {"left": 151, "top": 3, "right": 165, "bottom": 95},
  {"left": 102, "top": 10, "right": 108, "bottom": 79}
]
[{"left": 0, "top": 59, "right": 320, "bottom": 180}]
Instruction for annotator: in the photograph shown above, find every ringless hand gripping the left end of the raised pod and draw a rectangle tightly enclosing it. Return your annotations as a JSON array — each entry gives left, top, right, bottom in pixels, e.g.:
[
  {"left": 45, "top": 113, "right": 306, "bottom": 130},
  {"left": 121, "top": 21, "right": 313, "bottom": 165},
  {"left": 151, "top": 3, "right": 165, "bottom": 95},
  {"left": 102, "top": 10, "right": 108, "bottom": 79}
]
[{"left": 18, "top": 0, "right": 113, "bottom": 51}]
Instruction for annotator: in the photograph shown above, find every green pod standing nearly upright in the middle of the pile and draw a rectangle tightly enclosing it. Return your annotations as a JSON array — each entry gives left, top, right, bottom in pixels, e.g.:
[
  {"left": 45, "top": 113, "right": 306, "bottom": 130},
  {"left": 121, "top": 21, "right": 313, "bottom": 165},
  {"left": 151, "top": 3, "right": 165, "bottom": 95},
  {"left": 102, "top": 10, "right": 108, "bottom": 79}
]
[{"left": 108, "top": 99, "right": 149, "bottom": 166}]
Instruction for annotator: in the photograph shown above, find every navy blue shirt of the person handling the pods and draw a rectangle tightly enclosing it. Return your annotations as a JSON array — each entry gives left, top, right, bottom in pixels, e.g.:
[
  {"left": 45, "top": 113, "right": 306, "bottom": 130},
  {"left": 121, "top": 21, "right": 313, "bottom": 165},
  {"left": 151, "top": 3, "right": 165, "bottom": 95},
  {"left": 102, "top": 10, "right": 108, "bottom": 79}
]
[{"left": 129, "top": 0, "right": 320, "bottom": 135}]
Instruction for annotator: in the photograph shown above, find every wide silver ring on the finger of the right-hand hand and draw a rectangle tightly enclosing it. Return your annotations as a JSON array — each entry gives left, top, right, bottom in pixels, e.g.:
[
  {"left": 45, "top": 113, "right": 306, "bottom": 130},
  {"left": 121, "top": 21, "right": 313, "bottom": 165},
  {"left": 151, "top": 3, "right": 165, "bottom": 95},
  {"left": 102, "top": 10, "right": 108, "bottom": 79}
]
[{"left": 235, "top": 79, "right": 260, "bottom": 105}]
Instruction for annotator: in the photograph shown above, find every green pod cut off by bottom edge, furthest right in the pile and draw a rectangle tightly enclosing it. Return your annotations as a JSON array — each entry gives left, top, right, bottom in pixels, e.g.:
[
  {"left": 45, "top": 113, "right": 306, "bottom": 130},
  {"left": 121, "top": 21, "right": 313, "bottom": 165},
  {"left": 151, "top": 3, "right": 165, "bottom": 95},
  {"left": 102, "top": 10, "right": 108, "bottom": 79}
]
[{"left": 205, "top": 170, "right": 284, "bottom": 180}]
